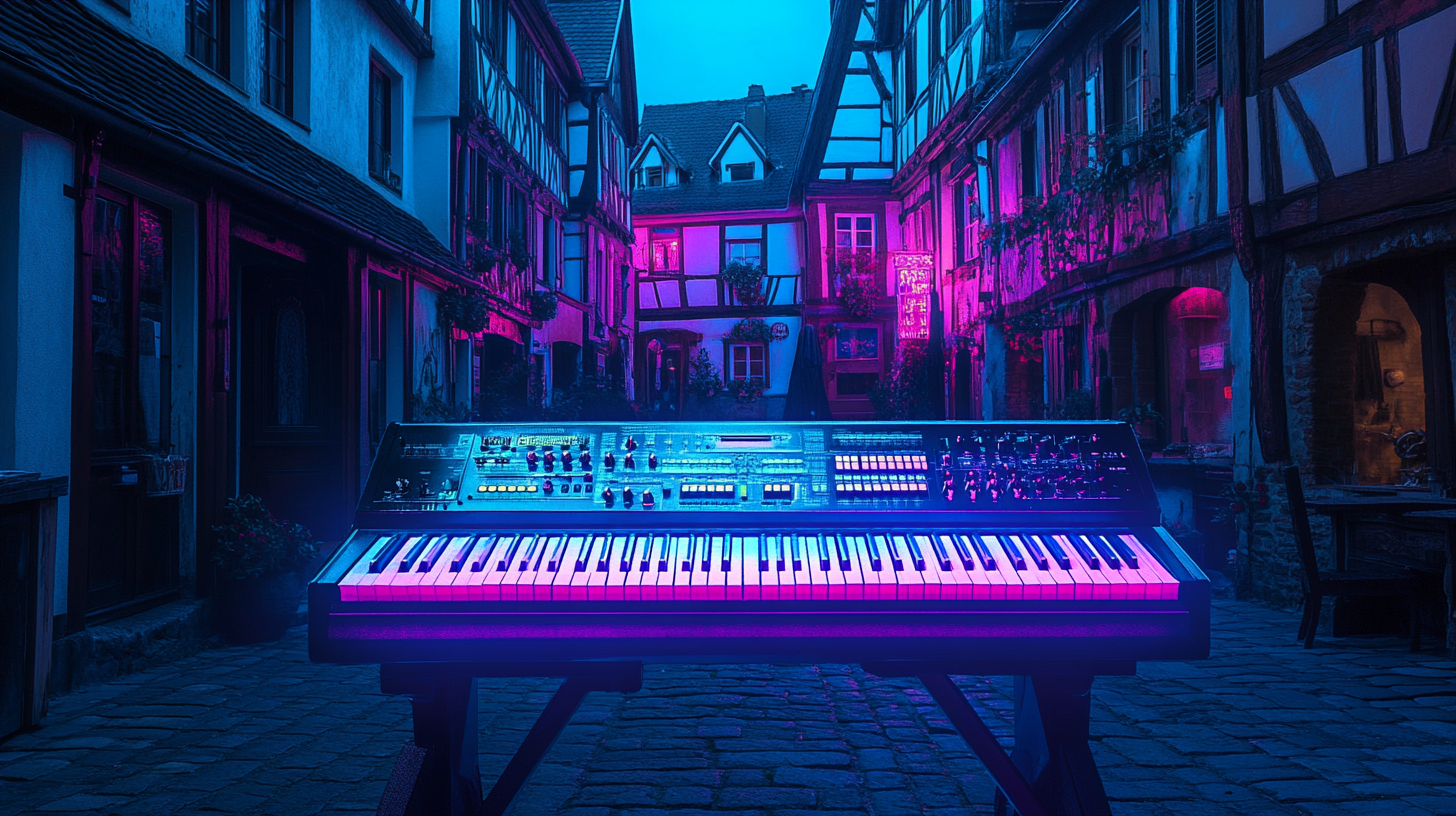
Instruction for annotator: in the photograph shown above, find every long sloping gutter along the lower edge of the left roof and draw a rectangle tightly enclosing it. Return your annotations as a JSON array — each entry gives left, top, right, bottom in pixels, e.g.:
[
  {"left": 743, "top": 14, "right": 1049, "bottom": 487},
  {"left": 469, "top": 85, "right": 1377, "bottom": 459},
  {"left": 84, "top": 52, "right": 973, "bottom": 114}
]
[{"left": 0, "top": 60, "right": 460, "bottom": 277}]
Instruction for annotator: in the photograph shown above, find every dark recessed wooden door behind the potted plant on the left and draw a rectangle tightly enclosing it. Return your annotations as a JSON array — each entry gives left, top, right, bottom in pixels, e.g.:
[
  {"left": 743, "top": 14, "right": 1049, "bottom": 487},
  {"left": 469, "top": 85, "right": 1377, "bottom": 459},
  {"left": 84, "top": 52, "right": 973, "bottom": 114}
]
[{"left": 239, "top": 261, "right": 354, "bottom": 544}]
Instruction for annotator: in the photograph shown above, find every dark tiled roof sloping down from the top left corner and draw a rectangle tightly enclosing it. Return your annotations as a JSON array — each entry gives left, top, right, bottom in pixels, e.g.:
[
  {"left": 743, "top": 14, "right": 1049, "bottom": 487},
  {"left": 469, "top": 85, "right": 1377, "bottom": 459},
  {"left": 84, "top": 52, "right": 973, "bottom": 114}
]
[{"left": 0, "top": 0, "right": 459, "bottom": 270}]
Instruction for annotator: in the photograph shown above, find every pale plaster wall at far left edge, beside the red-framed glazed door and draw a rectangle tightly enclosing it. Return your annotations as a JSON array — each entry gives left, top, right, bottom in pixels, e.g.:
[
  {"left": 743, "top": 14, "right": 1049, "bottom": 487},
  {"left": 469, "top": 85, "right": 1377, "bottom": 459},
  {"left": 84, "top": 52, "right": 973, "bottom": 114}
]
[{"left": 0, "top": 122, "right": 76, "bottom": 613}]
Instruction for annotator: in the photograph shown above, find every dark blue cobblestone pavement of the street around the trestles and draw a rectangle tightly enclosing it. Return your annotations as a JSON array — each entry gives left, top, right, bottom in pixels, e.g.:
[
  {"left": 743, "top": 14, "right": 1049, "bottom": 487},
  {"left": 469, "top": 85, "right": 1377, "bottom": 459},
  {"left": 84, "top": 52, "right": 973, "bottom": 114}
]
[{"left": 0, "top": 600, "right": 1456, "bottom": 816}]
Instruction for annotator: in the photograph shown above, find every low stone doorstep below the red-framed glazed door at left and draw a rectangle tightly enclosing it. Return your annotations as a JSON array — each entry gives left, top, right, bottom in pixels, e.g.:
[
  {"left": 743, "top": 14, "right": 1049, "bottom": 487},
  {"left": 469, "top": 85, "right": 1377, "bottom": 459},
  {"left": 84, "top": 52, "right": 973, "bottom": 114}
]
[{"left": 50, "top": 599, "right": 218, "bottom": 698}]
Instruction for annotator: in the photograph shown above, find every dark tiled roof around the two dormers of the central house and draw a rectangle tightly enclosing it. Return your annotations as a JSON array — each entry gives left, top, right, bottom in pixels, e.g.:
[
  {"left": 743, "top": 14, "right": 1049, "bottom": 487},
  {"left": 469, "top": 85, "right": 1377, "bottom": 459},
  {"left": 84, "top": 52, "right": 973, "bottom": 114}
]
[{"left": 632, "top": 90, "right": 811, "bottom": 216}]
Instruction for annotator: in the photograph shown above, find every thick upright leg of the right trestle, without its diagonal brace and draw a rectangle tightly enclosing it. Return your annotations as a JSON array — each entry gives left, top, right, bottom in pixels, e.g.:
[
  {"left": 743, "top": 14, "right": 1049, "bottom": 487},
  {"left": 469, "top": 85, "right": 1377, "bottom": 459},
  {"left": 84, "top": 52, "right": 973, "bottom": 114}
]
[{"left": 1012, "top": 676, "right": 1112, "bottom": 816}]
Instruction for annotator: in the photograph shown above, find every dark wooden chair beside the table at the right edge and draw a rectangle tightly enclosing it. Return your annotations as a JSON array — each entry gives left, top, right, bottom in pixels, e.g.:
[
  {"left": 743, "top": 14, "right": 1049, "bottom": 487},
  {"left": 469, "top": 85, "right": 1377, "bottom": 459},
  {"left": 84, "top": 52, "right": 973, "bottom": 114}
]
[{"left": 1284, "top": 465, "right": 1437, "bottom": 651}]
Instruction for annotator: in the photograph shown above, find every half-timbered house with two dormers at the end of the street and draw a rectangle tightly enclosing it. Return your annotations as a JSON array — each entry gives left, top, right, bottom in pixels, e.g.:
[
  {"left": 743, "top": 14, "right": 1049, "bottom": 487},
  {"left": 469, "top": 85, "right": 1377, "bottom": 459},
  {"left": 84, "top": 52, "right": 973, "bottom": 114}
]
[{"left": 630, "top": 85, "right": 810, "bottom": 418}]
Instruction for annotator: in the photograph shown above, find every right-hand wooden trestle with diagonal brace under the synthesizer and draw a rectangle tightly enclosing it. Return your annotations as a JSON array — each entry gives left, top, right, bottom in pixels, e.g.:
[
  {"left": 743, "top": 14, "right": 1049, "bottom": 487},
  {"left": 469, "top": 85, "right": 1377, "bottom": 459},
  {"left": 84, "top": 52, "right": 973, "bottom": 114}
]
[{"left": 865, "top": 662, "right": 1136, "bottom": 816}]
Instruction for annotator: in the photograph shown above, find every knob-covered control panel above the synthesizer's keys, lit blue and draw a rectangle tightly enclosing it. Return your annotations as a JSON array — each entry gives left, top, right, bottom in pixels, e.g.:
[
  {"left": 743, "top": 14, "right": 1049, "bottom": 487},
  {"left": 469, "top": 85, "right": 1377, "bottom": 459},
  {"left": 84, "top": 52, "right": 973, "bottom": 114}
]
[{"left": 360, "top": 423, "right": 1156, "bottom": 511}]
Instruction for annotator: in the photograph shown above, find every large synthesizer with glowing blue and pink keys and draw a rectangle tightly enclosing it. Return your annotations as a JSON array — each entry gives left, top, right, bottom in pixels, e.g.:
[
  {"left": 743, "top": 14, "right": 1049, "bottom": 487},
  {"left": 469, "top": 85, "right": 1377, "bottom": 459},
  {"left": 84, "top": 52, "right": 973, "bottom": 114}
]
[{"left": 309, "top": 423, "right": 1210, "bottom": 813}]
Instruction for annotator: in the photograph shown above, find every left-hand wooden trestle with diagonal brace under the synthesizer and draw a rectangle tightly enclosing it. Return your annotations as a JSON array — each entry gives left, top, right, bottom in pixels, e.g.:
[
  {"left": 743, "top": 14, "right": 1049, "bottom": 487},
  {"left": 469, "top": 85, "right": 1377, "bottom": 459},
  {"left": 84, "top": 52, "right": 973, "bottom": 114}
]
[{"left": 379, "top": 662, "right": 642, "bottom": 816}]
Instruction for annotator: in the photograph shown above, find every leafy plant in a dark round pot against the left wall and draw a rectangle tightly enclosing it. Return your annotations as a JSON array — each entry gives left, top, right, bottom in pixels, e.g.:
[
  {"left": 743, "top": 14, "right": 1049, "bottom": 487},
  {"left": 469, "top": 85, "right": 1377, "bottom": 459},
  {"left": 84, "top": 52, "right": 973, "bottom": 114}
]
[{"left": 213, "top": 495, "right": 319, "bottom": 643}]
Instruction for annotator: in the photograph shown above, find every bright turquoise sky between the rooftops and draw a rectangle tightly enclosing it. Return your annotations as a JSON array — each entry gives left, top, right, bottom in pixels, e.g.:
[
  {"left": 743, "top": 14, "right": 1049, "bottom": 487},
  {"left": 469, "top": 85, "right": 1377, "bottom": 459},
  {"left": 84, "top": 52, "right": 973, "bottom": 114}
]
[{"left": 632, "top": 0, "right": 830, "bottom": 105}]
